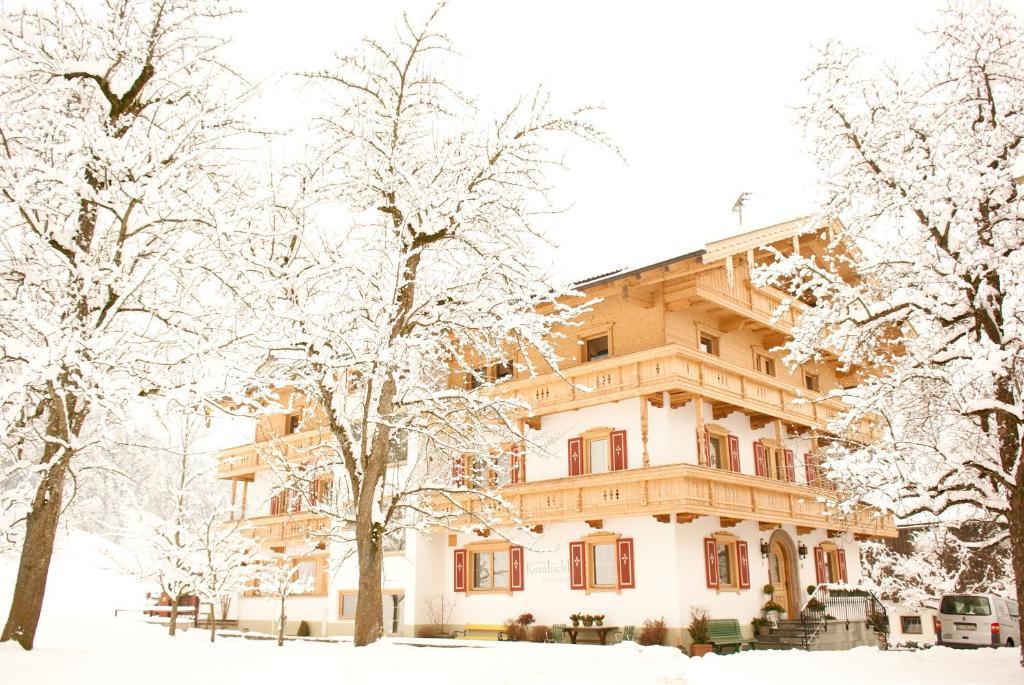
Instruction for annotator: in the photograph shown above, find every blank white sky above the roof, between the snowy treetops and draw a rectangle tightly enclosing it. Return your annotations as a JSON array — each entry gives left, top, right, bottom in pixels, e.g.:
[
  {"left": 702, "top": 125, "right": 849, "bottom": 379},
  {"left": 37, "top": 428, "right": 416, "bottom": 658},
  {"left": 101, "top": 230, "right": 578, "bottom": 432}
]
[{"left": 220, "top": 0, "right": 1024, "bottom": 276}]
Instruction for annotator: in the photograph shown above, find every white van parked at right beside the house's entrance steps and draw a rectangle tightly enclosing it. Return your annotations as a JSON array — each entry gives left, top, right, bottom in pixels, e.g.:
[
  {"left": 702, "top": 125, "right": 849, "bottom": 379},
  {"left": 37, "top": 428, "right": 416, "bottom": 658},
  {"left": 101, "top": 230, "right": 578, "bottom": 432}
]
[{"left": 935, "top": 595, "right": 1021, "bottom": 647}]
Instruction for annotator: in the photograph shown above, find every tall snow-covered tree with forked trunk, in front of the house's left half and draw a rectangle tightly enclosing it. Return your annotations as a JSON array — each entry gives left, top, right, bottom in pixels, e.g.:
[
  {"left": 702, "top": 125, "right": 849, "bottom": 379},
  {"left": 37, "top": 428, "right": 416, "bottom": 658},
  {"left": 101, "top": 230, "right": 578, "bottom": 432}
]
[{"left": 239, "top": 3, "right": 606, "bottom": 645}]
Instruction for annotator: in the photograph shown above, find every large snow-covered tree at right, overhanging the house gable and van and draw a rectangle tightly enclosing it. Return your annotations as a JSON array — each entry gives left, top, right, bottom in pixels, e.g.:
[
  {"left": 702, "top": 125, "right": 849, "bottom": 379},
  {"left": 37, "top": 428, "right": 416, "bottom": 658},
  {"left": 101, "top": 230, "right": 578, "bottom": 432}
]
[{"left": 760, "top": 2, "right": 1024, "bottom": 662}]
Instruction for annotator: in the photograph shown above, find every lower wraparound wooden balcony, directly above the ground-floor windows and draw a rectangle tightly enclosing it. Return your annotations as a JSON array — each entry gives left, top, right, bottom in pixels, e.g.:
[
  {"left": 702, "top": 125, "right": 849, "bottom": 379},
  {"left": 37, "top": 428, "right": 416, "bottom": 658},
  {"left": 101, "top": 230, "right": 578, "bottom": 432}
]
[{"left": 447, "top": 464, "right": 896, "bottom": 538}]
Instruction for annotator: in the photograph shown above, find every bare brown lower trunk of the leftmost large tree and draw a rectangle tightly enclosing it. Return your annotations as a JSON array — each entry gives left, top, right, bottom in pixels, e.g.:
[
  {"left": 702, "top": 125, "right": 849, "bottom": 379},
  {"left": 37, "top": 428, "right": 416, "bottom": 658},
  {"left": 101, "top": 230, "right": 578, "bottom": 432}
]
[{"left": 0, "top": 442, "right": 72, "bottom": 649}]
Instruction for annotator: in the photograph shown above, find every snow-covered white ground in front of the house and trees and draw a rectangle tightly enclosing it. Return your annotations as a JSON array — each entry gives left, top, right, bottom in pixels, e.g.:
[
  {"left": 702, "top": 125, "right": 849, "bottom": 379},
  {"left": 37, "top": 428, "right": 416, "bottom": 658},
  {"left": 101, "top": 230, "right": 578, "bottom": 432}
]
[{"left": 0, "top": 533, "right": 1024, "bottom": 685}]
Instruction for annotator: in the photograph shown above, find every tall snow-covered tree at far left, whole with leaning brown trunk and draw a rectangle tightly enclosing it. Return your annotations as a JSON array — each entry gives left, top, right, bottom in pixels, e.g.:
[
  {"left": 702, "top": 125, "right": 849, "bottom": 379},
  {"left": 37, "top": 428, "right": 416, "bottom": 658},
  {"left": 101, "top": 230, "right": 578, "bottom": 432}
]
[{"left": 0, "top": 0, "right": 251, "bottom": 649}]
